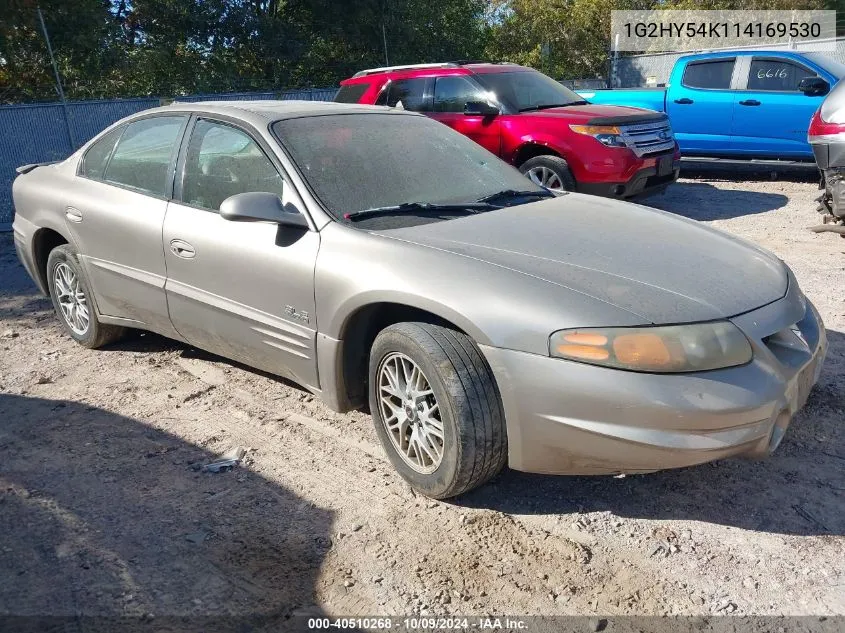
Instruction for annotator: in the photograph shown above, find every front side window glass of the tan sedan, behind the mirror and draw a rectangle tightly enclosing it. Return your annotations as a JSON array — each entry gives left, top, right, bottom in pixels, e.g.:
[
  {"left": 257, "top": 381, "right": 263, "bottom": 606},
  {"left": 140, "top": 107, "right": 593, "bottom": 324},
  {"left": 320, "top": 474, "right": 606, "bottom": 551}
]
[{"left": 182, "top": 119, "right": 283, "bottom": 211}]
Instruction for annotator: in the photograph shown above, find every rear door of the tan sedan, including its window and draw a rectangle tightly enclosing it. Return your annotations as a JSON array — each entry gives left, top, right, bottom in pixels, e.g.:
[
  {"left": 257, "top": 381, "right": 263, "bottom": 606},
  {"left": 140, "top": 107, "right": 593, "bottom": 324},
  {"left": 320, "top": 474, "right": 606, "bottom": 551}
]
[{"left": 65, "top": 114, "right": 188, "bottom": 336}]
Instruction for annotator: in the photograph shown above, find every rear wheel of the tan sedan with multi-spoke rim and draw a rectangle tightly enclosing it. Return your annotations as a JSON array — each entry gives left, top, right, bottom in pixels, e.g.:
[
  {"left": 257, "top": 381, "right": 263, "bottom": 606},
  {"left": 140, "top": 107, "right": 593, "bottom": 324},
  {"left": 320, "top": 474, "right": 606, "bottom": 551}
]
[{"left": 47, "top": 244, "right": 126, "bottom": 349}]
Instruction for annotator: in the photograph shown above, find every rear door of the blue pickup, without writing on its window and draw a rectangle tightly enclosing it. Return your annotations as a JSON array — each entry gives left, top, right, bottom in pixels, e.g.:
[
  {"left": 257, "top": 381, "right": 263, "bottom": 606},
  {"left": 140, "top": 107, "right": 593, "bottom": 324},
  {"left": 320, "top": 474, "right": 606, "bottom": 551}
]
[{"left": 666, "top": 57, "right": 736, "bottom": 154}]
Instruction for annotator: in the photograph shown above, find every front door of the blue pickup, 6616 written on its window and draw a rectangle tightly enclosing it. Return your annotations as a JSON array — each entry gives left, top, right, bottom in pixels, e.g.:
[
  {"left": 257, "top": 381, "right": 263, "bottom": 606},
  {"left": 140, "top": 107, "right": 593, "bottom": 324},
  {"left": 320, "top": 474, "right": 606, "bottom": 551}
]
[{"left": 732, "top": 55, "right": 824, "bottom": 158}]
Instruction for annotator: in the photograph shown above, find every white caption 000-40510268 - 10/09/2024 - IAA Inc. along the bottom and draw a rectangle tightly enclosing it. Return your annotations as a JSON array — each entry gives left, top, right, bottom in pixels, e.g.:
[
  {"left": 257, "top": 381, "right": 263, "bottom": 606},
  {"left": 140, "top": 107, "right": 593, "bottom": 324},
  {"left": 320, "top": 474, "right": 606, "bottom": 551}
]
[{"left": 308, "top": 617, "right": 528, "bottom": 631}]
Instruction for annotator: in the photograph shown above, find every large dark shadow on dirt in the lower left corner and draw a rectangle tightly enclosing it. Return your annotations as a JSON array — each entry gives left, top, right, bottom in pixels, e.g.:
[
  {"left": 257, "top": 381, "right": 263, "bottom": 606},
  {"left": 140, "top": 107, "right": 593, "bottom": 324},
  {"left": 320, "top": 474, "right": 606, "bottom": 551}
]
[{"left": 0, "top": 394, "right": 333, "bottom": 631}]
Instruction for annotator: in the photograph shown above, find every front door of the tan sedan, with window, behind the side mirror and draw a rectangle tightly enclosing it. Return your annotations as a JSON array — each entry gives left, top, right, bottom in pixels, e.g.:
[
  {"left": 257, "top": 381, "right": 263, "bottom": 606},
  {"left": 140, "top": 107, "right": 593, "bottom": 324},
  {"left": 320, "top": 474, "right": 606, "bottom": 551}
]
[{"left": 163, "top": 116, "right": 320, "bottom": 388}]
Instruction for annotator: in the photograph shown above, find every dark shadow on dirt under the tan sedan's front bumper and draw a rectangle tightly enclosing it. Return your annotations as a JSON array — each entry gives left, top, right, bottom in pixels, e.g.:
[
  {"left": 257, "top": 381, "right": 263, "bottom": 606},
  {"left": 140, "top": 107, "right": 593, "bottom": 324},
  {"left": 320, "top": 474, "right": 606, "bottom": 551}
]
[{"left": 457, "top": 330, "right": 845, "bottom": 535}]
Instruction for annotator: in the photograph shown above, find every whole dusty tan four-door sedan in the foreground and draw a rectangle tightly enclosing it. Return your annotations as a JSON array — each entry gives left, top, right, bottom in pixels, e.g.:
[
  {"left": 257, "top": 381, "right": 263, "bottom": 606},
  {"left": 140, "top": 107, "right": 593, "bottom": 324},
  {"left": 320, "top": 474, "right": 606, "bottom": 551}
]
[{"left": 14, "top": 102, "right": 826, "bottom": 497}]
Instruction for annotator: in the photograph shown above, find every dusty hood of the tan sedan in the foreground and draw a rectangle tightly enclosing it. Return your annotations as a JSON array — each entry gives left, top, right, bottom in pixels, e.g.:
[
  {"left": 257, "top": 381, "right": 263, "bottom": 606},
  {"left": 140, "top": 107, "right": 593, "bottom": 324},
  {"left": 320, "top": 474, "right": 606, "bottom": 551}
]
[{"left": 377, "top": 194, "right": 788, "bottom": 325}]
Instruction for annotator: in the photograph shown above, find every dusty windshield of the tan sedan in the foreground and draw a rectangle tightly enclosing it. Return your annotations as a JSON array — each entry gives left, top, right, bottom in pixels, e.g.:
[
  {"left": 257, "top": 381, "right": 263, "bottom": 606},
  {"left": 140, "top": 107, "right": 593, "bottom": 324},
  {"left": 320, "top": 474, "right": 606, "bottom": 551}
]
[{"left": 273, "top": 112, "right": 543, "bottom": 218}]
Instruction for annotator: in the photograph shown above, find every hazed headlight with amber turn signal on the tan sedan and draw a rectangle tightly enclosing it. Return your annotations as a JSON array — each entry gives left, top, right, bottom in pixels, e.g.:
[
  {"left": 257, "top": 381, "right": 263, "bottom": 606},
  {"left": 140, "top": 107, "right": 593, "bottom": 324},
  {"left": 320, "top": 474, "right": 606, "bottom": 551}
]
[{"left": 549, "top": 321, "right": 753, "bottom": 374}]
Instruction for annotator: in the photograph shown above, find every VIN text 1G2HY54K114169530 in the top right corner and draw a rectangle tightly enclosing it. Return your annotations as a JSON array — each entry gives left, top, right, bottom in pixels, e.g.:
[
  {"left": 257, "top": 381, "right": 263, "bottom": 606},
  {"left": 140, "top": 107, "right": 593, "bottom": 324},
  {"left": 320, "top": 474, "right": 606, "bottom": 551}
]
[{"left": 624, "top": 22, "right": 822, "bottom": 39}]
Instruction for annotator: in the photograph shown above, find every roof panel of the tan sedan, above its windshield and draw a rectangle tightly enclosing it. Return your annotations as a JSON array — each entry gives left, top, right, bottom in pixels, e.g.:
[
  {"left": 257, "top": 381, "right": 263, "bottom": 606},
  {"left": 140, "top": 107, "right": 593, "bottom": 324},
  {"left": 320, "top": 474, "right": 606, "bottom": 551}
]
[{"left": 140, "top": 100, "right": 416, "bottom": 126}]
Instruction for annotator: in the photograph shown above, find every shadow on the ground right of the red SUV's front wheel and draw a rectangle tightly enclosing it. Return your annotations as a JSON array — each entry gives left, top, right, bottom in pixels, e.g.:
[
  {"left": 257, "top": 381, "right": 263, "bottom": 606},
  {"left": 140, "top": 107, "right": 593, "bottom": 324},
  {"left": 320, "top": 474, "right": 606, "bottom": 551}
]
[{"left": 641, "top": 182, "right": 789, "bottom": 221}]
